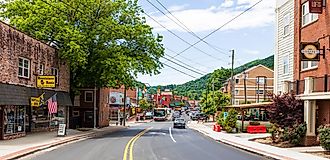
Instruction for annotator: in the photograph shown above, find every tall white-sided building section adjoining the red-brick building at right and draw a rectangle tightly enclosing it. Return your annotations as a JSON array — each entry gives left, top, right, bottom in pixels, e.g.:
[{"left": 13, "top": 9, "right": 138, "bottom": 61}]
[{"left": 274, "top": 0, "right": 294, "bottom": 94}]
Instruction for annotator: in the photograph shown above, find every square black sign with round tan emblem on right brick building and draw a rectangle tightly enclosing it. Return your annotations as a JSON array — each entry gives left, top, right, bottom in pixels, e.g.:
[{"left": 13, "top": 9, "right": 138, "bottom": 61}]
[{"left": 300, "top": 42, "right": 320, "bottom": 61}]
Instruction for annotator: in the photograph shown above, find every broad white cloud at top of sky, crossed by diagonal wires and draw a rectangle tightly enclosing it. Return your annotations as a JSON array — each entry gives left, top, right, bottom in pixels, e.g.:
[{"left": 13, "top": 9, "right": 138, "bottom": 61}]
[{"left": 147, "top": 0, "right": 275, "bottom": 32}]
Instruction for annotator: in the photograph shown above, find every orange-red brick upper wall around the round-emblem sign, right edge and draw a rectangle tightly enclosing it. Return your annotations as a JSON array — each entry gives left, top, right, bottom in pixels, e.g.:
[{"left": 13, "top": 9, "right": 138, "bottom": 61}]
[{"left": 294, "top": 0, "right": 330, "bottom": 80}]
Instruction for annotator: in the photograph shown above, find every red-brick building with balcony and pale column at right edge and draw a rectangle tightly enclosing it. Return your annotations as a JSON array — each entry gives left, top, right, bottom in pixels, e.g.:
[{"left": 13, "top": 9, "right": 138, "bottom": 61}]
[{"left": 286, "top": 0, "right": 330, "bottom": 145}]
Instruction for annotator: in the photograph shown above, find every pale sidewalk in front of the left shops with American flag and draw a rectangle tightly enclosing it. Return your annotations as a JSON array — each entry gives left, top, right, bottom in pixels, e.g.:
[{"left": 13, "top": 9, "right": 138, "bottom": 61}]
[{"left": 0, "top": 126, "right": 125, "bottom": 160}]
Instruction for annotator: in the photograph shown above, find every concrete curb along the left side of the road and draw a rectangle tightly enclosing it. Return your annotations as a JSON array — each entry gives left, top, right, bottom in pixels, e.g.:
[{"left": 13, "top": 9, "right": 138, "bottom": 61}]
[{"left": 0, "top": 127, "right": 127, "bottom": 160}]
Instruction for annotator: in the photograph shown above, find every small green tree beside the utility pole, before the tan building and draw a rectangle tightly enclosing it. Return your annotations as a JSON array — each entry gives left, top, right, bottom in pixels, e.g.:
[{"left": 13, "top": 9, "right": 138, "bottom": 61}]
[{"left": 201, "top": 91, "right": 230, "bottom": 118}]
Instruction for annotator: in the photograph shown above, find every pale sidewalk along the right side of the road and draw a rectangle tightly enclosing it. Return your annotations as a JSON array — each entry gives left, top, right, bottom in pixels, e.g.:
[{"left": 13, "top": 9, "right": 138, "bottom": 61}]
[{"left": 188, "top": 122, "right": 329, "bottom": 160}]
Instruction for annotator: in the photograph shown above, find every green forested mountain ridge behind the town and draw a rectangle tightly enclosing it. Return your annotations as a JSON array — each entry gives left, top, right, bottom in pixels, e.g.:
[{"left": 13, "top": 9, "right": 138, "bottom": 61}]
[{"left": 149, "top": 55, "right": 274, "bottom": 100}]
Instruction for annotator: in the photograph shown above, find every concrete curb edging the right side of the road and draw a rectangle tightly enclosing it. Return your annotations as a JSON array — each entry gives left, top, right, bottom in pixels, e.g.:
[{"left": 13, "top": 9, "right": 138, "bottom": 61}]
[{"left": 189, "top": 127, "right": 296, "bottom": 160}]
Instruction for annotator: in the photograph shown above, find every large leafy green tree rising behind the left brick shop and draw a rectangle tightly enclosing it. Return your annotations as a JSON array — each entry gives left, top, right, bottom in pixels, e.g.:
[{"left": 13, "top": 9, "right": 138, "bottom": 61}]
[{"left": 0, "top": 0, "right": 164, "bottom": 88}]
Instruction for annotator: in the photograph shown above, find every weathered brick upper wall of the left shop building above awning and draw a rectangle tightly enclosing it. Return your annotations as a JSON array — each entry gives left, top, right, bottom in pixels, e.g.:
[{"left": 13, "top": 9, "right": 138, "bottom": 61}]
[{"left": 0, "top": 22, "right": 70, "bottom": 92}]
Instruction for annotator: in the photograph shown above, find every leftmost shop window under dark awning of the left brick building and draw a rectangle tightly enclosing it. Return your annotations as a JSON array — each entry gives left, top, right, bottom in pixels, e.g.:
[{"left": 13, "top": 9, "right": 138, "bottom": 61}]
[{"left": 4, "top": 106, "right": 25, "bottom": 134}]
